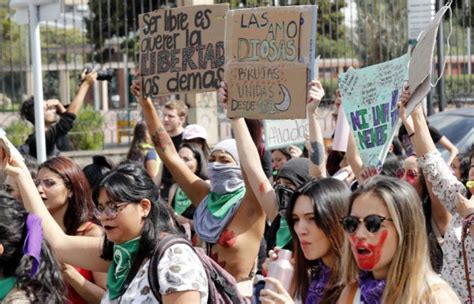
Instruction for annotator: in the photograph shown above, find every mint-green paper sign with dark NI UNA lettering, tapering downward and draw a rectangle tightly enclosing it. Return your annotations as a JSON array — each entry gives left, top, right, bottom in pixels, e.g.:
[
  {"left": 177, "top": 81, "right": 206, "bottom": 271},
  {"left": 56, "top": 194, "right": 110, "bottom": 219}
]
[{"left": 338, "top": 55, "right": 409, "bottom": 167}]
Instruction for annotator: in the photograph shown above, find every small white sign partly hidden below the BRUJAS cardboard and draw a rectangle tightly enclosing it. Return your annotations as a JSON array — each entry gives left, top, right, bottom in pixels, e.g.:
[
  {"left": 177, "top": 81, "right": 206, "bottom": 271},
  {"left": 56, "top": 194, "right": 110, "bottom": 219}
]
[{"left": 263, "top": 119, "right": 308, "bottom": 150}]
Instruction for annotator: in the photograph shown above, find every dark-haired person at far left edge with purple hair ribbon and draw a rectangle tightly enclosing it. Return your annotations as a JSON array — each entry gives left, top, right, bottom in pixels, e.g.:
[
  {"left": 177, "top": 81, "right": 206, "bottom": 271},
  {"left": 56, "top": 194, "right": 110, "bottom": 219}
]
[{"left": 0, "top": 194, "right": 66, "bottom": 303}]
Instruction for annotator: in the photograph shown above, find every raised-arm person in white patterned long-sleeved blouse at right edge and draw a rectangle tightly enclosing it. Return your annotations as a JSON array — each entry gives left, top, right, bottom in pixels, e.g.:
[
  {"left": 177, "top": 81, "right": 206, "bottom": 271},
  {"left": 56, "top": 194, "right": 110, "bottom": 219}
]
[{"left": 400, "top": 93, "right": 474, "bottom": 301}]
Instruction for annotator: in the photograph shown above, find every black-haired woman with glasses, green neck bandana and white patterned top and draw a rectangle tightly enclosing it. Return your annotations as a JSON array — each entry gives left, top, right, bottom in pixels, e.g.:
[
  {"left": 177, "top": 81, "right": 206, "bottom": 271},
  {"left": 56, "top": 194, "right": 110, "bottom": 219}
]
[{"left": 0, "top": 153, "right": 209, "bottom": 304}]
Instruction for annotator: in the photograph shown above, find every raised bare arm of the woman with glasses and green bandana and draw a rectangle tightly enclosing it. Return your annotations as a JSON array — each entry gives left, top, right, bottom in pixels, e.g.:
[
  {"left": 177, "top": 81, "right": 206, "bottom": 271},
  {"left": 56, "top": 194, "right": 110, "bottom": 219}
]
[{"left": 0, "top": 150, "right": 109, "bottom": 272}]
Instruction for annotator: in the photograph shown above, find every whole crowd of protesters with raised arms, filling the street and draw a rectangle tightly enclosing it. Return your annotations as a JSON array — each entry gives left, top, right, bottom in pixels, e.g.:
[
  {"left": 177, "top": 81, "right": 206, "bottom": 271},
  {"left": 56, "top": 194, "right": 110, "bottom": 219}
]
[{"left": 0, "top": 68, "right": 474, "bottom": 304}]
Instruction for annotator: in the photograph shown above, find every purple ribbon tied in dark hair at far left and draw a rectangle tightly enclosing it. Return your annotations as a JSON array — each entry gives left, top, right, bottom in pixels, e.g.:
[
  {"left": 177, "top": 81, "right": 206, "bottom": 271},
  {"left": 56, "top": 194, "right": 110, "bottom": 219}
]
[{"left": 23, "top": 214, "right": 43, "bottom": 276}]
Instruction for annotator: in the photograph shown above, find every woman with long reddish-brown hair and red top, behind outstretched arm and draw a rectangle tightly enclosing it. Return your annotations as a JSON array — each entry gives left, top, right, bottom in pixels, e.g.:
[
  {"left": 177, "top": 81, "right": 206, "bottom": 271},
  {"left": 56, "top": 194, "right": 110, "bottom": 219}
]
[{"left": 36, "top": 156, "right": 107, "bottom": 304}]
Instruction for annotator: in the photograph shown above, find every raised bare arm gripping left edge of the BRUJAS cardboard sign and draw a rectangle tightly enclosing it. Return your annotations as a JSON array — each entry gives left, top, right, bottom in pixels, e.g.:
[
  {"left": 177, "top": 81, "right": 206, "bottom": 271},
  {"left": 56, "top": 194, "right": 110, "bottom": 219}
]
[{"left": 219, "top": 83, "right": 278, "bottom": 221}]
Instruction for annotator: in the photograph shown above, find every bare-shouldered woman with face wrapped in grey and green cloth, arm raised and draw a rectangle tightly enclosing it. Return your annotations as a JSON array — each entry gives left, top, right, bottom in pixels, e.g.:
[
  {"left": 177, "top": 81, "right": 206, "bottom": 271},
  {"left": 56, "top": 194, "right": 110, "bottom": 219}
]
[{"left": 131, "top": 82, "right": 265, "bottom": 296}]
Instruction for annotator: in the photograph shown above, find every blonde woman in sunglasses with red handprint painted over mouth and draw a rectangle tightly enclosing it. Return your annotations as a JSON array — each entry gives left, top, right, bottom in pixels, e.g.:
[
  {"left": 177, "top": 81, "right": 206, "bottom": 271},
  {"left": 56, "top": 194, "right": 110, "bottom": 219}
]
[{"left": 339, "top": 176, "right": 460, "bottom": 304}]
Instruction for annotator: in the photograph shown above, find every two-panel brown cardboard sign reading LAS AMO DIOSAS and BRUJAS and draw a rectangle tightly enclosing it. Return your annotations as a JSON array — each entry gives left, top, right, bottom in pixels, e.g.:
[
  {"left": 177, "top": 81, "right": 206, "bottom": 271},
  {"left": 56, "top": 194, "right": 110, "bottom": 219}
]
[{"left": 225, "top": 5, "right": 316, "bottom": 119}]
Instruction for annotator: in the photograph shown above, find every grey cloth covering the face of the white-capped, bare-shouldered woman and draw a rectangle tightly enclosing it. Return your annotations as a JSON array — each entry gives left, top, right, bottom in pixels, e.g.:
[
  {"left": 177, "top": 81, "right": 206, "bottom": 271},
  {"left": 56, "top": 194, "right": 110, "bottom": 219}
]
[{"left": 207, "top": 162, "right": 244, "bottom": 194}]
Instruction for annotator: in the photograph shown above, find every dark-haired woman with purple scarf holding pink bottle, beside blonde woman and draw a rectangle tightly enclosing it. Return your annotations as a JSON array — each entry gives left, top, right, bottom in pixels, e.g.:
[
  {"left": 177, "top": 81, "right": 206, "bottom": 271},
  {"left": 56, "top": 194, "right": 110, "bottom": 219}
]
[{"left": 260, "top": 178, "right": 350, "bottom": 304}]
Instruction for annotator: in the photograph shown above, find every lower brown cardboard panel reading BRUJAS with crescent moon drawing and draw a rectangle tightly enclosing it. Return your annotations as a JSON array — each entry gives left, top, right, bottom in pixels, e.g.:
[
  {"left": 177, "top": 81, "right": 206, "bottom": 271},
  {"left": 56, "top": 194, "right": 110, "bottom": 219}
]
[{"left": 226, "top": 63, "right": 308, "bottom": 119}]
